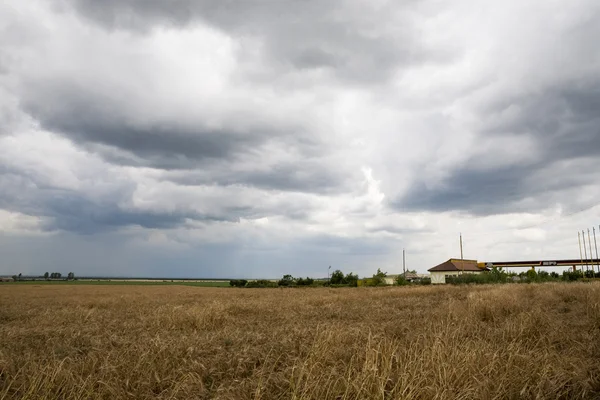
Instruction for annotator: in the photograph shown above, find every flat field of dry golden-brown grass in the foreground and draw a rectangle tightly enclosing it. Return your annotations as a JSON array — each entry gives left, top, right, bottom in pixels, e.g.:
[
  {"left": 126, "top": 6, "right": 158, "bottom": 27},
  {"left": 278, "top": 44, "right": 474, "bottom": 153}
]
[{"left": 0, "top": 283, "right": 600, "bottom": 399}]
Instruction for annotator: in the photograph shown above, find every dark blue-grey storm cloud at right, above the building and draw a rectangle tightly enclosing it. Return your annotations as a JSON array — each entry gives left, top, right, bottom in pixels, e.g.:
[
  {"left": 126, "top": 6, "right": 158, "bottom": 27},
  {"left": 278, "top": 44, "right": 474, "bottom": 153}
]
[{"left": 392, "top": 83, "right": 600, "bottom": 215}]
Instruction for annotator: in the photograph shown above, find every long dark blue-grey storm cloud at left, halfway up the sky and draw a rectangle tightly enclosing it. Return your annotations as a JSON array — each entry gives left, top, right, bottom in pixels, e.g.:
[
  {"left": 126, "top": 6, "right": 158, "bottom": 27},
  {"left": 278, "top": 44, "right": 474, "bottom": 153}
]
[{"left": 21, "top": 79, "right": 302, "bottom": 169}]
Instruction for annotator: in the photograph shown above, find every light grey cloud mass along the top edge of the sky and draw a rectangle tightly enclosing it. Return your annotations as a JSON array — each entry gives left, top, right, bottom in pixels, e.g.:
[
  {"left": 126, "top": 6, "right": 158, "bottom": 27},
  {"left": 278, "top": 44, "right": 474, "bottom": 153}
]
[{"left": 67, "top": 0, "right": 442, "bottom": 83}]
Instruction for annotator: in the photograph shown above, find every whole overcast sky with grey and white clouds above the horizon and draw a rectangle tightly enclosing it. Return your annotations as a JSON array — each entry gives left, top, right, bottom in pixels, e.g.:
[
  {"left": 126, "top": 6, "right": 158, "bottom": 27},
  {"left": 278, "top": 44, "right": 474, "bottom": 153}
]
[{"left": 0, "top": 0, "right": 600, "bottom": 278}]
